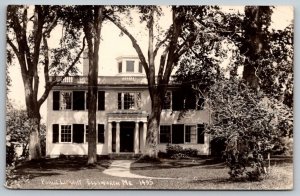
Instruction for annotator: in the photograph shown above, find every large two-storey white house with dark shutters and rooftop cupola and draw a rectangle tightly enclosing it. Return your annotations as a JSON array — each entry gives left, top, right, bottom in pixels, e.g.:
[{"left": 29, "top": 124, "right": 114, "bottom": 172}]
[{"left": 46, "top": 56, "right": 210, "bottom": 157}]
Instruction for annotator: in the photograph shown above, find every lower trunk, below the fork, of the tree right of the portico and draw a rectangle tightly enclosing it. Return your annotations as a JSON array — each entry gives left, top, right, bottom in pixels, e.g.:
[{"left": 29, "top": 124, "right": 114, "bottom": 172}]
[{"left": 144, "top": 89, "right": 162, "bottom": 158}]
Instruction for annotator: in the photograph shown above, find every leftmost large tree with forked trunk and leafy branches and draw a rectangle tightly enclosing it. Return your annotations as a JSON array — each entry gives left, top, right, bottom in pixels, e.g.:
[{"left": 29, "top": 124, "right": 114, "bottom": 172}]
[{"left": 7, "top": 5, "right": 84, "bottom": 159}]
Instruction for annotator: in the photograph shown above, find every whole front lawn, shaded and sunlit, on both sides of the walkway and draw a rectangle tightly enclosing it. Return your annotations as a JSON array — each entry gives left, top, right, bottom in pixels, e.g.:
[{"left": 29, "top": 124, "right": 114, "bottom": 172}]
[{"left": 5, "top": 155, "right": 293, "bottom": 190}]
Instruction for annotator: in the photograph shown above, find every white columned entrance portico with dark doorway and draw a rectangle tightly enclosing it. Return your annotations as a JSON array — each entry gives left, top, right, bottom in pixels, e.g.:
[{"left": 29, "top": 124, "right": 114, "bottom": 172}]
[{"left": 107, "top": 112, "right": 148, "bottom": 154}]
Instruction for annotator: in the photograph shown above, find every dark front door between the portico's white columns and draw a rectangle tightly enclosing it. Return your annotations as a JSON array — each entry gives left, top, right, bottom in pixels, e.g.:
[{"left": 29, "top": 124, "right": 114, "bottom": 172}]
[{"left": 120, "top": 122, "right": 135, "bottom": 152}]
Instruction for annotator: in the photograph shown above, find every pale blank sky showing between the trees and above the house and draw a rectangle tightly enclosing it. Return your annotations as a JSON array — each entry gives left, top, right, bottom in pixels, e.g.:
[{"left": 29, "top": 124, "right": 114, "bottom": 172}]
[{"left": 8, "top": 6, "right": 293, "bottom": 121}]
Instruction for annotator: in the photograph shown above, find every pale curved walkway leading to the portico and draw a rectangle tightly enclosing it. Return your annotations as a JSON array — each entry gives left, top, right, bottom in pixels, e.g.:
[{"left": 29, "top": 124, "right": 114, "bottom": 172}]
[{"left": 103, "top": 160, "right": 171, "bottom": 179}]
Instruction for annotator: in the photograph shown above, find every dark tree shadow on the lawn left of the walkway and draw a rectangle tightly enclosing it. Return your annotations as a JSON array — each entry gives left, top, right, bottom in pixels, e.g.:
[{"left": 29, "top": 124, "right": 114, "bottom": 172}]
[{"left": 16, "top": 157, "right": 111, "bottom": 179}]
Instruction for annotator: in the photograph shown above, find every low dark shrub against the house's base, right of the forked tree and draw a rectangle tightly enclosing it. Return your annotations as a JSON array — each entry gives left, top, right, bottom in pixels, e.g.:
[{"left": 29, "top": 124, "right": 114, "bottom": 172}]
[{"left": 166, "top": 144, "right": 198, "bottom": 159}]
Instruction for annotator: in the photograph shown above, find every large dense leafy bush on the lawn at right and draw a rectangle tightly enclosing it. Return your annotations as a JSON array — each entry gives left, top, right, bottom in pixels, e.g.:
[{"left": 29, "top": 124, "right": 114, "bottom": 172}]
[{"left": 208, "top": 78, "right": 293, "bottom": 180}]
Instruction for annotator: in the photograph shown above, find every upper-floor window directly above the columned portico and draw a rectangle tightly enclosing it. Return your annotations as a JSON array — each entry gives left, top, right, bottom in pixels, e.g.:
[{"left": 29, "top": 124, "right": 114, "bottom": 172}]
[{"left": 118, "top": 92, "right": 141, "bottom": 110}]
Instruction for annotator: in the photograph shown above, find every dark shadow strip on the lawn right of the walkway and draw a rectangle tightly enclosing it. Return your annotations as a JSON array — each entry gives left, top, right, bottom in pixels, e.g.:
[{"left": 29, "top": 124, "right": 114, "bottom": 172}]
[{"left": 130, "top": 158, "right": 226, "bottom": 170}]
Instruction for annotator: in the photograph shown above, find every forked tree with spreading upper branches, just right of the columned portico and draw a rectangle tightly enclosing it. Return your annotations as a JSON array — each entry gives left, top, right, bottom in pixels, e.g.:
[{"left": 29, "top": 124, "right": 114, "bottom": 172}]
[{"left": 107, "top": 6, "right": 209, "bottom": 157}]
